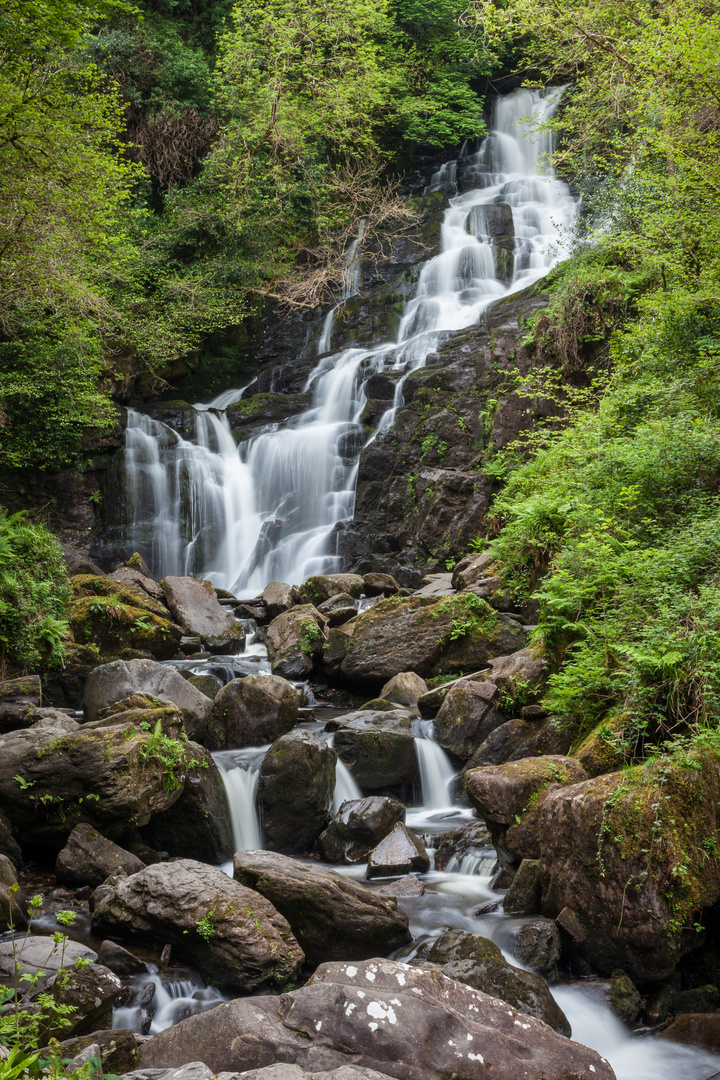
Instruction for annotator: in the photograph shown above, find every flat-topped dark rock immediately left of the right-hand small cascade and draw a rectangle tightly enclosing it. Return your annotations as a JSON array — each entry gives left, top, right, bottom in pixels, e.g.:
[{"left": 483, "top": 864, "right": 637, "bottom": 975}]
[{"left": 332, "top": 710, "right": 419, "bottom": 791}]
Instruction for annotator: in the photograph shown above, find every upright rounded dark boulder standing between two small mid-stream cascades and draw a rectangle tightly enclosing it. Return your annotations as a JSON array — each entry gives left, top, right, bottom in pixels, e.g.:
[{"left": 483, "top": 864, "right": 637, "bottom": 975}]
[{"left": 258, "top": 729, "right": 337, "bottom": 854}]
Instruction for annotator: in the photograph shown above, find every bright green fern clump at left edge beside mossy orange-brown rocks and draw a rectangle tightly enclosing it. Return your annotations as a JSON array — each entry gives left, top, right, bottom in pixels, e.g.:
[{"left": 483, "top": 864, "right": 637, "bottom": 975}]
[{"left": 0, "top": 511, "right": 72, "bottom": 673}]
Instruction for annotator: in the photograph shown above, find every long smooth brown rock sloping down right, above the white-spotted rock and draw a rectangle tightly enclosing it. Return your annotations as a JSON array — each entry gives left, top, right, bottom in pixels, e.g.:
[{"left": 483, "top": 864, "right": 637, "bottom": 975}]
[{"left": 233, "top": 851, "right": 410, "bottom": 964}]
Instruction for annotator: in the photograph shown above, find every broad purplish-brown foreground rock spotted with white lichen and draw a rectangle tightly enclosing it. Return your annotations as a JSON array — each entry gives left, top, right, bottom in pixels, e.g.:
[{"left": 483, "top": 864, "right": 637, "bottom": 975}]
[{"left": 134, "top": 960, "right": 613, "bottom": 1080}]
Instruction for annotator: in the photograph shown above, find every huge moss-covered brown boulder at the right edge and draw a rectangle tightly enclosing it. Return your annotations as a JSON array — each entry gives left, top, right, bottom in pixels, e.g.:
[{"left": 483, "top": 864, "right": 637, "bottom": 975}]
[{"left": 500, "top": 748, "right": 720, "bottom": 982}]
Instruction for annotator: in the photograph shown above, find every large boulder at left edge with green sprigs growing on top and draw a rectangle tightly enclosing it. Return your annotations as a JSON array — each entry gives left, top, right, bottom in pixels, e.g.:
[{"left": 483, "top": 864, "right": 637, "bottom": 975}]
[{"left": 0, "top": 721, "right": 189, "bottom": 856}]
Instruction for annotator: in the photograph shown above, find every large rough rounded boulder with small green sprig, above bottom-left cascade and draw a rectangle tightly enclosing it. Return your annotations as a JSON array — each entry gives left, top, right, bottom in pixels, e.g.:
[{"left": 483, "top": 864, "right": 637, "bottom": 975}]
[{"left": 92, "top": 859, "right": 303, "bottom": 993}]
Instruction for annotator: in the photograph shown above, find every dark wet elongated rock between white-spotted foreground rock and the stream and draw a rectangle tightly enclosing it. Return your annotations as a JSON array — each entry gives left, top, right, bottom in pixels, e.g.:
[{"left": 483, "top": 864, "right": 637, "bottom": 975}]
[{"left": 427, "top": 930, "right": 570, "bottom": 1037}]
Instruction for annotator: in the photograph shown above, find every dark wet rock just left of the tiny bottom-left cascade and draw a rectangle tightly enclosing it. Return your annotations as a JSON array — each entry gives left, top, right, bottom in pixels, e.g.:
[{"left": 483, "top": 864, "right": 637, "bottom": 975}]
[{"left": 38, "top": 963, "right": 123, "bottom": 1047}]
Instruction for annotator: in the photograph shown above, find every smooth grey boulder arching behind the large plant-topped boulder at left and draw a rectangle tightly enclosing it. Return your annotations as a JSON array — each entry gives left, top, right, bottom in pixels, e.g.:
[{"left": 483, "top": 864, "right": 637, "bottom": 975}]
[{"left": 83, "top": 660, "right": 212, "bottom": 742}]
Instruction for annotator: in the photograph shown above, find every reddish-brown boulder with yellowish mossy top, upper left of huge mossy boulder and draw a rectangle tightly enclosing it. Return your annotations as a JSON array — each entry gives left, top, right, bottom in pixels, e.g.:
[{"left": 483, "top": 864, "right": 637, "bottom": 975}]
[{"left": 465, "top": 756, "right": 586, "bottom": 825}]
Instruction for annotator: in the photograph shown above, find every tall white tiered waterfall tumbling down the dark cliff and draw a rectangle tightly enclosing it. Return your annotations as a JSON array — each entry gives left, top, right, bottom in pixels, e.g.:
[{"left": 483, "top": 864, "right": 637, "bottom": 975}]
[{"left": 119, "top": 90, "right": 575, "bottom": 593}]
